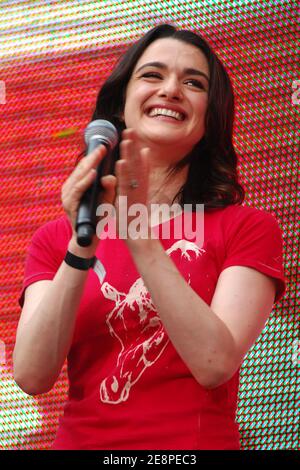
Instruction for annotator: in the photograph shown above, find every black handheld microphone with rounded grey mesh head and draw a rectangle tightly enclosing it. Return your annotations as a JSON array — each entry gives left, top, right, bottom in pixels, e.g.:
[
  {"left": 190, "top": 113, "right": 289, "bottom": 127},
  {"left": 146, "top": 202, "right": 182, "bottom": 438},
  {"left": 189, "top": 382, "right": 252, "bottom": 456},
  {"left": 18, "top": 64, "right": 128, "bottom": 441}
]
[{"left": 76, "top": 119, "right": 118, "bottom": 246}]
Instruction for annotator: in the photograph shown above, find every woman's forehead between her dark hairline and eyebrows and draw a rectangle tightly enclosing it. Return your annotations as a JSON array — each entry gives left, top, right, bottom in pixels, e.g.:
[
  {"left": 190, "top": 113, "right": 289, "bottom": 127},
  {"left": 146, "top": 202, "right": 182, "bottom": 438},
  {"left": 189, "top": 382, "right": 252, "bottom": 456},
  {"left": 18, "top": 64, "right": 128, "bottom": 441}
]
[{"left": 135, "top": 38, "right": 209, "bottom": 75}]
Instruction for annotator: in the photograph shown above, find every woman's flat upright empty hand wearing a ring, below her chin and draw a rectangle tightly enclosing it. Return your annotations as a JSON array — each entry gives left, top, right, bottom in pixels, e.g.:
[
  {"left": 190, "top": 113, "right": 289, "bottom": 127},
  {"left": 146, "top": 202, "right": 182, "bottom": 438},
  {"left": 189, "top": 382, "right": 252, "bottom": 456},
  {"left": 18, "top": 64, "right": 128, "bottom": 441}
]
[{"left": 116, "top": 129, "right": 150, "bottom": 240}]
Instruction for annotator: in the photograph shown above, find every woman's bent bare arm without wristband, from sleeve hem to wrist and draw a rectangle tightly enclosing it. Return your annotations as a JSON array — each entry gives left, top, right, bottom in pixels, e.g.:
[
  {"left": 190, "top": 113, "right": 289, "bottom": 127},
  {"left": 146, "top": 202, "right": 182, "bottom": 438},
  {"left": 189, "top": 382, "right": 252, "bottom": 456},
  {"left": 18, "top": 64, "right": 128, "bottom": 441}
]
[{"left": 128, "top": 240, "right": 275, "bottom": 388}]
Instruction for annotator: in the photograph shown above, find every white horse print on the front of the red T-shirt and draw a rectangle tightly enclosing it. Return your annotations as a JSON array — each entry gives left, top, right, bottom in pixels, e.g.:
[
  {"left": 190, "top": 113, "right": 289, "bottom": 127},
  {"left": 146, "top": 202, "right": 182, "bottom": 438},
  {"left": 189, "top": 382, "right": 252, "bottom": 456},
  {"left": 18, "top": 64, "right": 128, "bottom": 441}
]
[{"left": 100, "top": 240, "right": 205, "bottom": 404}]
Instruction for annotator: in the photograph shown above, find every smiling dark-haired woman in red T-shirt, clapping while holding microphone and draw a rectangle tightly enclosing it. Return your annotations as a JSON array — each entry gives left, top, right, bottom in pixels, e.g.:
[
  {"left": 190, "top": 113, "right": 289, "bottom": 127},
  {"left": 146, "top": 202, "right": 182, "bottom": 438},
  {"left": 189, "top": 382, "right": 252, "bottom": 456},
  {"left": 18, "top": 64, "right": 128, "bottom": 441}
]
[{"left": 14, "top": 25, "right": 285, "bottom": 449}]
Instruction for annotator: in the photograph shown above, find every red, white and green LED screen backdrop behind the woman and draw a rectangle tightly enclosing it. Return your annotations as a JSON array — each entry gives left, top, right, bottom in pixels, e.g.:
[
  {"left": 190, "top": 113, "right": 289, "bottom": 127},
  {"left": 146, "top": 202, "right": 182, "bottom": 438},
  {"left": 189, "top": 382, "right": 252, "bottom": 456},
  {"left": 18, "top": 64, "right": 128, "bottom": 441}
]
[{"left": 0, "top": 0, "right": 300, "bottom": 449}]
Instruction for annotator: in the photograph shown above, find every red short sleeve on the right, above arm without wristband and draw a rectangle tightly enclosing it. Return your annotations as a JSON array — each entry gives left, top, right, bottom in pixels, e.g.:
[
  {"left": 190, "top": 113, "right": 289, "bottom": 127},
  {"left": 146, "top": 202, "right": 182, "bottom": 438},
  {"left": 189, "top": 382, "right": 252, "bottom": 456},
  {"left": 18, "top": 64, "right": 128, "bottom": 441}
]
[{"left": 222, "top": 206, "right": 286, "bottom": 302}]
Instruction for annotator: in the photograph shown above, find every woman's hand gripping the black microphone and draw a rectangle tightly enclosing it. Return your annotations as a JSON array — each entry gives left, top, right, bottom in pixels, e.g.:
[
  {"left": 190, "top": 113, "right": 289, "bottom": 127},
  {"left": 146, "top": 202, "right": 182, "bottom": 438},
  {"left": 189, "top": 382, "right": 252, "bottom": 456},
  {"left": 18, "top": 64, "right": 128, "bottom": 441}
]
[{"left": 61, "top": 145, "right": 116, "bottom": 250}]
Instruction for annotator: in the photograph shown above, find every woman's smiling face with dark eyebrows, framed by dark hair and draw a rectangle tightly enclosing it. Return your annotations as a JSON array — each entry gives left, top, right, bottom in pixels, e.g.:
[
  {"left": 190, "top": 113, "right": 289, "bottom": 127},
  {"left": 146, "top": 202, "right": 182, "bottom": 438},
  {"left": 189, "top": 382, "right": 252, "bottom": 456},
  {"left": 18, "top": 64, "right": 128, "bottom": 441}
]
[{"left": 124, "top": 38, "right": 209, "bottom": 156}]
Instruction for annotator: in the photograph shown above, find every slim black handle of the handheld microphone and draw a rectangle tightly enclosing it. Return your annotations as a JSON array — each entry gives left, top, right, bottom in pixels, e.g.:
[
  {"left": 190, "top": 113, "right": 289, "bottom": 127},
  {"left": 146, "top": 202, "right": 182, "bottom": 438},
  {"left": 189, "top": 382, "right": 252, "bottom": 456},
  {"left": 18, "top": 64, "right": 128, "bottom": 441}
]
[{"left": 76, "top": 138, "right": 109, "bottom": 247}]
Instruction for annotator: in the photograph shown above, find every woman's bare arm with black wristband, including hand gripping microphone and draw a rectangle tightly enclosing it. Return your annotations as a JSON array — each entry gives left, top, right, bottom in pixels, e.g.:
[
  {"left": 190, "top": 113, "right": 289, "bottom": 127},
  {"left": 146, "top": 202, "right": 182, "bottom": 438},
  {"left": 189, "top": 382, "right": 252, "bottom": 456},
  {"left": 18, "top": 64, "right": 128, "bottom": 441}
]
[{"left": 13, "top": 148, "right": 115, "bottom": 395}]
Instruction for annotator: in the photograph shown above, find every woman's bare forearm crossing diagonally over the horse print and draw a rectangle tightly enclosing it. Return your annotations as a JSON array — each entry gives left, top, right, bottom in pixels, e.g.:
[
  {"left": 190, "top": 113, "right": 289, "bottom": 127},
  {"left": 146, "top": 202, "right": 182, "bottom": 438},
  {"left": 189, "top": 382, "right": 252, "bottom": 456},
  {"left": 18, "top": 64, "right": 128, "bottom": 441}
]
[{"left": 129, "top": 240, "right": 235, "bottom": 388}]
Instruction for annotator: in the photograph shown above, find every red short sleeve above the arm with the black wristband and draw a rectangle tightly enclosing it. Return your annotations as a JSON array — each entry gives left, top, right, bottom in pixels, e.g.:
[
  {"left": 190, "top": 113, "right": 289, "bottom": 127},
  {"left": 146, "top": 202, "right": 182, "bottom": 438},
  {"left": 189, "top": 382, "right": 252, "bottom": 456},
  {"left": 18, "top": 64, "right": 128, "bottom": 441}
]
[{"left": 19, "top": 216, "right": 72, "bottom": 307}]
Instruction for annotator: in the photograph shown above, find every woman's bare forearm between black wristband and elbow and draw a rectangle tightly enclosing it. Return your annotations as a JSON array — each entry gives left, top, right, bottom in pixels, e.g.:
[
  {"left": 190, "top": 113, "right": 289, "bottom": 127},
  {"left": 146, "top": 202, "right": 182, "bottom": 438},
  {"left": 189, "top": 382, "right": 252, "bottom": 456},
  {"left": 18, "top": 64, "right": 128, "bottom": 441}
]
[{"left": 14, "top": 237, "right": 94, "bottom": 394}]
